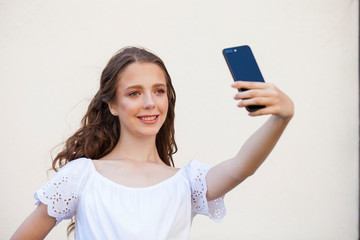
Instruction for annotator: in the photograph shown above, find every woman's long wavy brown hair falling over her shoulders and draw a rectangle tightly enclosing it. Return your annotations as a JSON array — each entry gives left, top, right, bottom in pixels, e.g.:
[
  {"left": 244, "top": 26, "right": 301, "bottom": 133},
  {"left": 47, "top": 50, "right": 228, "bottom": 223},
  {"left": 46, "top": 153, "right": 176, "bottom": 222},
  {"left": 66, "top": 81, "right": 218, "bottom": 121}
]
[{"left": 52, "top": 47, "right": 177, "bottom": 234}]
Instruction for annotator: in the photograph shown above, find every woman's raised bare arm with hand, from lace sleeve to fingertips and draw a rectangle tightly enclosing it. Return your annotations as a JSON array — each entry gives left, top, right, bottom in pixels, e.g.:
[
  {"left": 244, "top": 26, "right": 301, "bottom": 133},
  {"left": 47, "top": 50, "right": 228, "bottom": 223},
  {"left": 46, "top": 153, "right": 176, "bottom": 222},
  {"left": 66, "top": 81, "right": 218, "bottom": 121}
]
[{"left": 206, "top": 81, "right": 294, "bottom": 201}]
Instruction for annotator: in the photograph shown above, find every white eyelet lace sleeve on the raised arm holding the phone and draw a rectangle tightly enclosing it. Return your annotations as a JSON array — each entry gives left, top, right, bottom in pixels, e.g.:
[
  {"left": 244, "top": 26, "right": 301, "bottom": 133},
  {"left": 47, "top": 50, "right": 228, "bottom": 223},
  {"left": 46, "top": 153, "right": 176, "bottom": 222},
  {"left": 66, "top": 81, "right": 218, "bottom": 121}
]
[{"left": 186, "top": 159, "right": 226, "bottom": 222}]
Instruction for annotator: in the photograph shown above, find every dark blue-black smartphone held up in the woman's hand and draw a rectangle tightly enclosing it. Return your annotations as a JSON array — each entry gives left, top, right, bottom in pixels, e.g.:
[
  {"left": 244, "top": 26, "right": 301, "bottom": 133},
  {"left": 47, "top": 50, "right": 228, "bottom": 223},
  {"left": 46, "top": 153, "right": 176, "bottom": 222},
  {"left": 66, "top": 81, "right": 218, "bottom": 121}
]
[{"left": 223, "top": 45, "right": 265, "bottom": 112}]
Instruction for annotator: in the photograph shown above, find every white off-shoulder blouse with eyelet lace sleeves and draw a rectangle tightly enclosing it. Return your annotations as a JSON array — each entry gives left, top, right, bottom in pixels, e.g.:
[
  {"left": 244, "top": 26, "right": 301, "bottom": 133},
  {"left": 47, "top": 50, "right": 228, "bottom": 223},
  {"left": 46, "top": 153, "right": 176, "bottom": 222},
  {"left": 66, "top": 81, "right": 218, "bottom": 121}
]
[{"left": 34, "top": 158, "right": 226, "bottom": 240}]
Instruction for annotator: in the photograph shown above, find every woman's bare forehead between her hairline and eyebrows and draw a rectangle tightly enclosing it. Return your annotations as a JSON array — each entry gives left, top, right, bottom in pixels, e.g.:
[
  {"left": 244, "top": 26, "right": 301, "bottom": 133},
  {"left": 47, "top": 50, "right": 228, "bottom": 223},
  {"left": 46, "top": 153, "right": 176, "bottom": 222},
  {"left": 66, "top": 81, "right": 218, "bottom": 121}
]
[{"left": 118, "top": 62, "right": 166, "bottom": 88}]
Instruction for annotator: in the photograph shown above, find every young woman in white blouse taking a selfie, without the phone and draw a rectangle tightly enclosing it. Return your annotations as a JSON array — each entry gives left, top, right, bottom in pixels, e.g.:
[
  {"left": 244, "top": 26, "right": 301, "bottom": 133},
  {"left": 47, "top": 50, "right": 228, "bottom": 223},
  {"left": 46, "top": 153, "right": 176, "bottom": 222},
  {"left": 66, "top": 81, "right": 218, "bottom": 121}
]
[{"left": 12, "top": 47, "right": 294, "bottom": 240}]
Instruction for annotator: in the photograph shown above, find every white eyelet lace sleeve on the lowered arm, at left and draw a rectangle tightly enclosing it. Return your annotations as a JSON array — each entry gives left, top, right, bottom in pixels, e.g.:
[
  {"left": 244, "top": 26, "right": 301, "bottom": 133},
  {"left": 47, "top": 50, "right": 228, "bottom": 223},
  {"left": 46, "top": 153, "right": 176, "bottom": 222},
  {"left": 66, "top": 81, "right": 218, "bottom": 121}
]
[{"left": 34, "top": 158, "right": 91, "bottom": 224}]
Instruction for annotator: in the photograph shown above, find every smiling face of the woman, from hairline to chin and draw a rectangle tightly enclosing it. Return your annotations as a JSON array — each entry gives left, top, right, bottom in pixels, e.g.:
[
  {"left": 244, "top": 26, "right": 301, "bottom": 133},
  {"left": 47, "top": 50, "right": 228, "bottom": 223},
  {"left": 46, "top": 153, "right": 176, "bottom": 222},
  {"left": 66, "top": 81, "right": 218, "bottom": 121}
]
[{"left": 109, "top": 63, "right": 168, "bottom": 139}]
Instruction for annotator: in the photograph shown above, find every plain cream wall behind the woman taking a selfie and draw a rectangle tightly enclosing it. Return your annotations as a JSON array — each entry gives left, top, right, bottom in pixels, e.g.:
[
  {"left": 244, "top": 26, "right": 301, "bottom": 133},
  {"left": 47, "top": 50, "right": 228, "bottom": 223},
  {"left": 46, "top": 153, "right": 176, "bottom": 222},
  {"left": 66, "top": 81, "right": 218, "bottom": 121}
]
[{"left": 0, "top": 0, "right": 359, "bottom": 240}]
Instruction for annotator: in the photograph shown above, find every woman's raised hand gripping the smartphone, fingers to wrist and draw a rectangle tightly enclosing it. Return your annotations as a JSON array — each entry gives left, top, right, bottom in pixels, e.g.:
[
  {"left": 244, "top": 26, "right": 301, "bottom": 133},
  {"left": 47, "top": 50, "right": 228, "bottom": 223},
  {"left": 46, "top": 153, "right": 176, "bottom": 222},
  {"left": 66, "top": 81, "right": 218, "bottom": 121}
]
[{"left": 231, "top": 81, "right": 294, "bottom": 120}]
